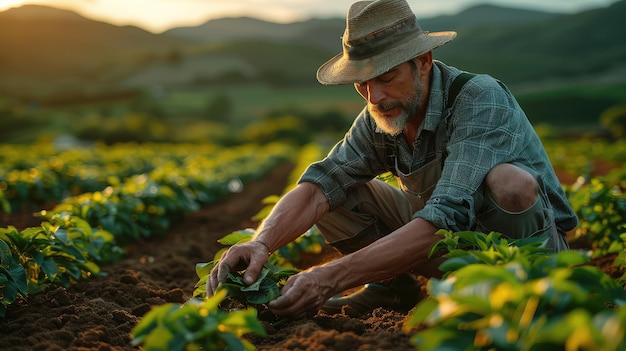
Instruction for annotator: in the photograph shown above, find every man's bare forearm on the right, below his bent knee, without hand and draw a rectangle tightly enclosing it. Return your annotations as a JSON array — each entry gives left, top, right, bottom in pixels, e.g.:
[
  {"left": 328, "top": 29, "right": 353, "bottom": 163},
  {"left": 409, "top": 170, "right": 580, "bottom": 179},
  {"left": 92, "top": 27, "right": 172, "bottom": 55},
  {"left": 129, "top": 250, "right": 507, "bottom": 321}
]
[{"left": 313, "top": 218, "right": 441, "bottom": 293}]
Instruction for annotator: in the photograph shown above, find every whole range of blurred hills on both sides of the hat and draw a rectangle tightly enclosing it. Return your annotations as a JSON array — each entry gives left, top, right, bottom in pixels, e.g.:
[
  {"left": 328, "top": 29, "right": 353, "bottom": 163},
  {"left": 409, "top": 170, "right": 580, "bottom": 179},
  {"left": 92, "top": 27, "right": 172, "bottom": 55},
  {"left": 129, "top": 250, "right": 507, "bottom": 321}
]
[{"left": 0, "top": 0, "right": 626, "bottom": 95}]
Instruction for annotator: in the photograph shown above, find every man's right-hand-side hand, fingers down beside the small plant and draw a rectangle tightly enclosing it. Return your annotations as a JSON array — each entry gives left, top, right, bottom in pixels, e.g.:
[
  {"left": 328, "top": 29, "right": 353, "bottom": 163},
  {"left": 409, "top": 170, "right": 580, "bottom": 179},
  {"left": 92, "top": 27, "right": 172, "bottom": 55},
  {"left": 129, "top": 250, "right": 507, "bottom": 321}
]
[{"left": 268, "top": 268, "right": 334, "bottom": 318}]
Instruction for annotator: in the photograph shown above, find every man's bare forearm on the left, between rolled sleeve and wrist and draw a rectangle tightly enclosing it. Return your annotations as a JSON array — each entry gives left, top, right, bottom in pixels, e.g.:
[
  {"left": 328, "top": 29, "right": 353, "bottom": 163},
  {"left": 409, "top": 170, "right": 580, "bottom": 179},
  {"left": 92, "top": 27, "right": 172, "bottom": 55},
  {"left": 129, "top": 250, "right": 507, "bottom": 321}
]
[{"left": 254, "top": 182, "right": 329, "bottom": 252}]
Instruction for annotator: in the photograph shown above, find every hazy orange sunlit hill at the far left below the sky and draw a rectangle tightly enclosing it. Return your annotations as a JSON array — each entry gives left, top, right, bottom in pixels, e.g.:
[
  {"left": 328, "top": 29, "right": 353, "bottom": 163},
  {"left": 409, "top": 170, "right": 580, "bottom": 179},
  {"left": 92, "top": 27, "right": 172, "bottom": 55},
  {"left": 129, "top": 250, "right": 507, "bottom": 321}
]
[{"left": 0, "top": 5, "right": 186, "bottom": 95}]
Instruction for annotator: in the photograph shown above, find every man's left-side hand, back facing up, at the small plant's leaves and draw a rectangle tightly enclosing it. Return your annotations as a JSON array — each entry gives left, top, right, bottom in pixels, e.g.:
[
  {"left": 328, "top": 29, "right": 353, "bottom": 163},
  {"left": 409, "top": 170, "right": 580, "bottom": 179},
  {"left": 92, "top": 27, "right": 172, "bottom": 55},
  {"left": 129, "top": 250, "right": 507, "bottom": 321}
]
[{"left": 206, "top": 240, "right": 269, "bottom": 296}]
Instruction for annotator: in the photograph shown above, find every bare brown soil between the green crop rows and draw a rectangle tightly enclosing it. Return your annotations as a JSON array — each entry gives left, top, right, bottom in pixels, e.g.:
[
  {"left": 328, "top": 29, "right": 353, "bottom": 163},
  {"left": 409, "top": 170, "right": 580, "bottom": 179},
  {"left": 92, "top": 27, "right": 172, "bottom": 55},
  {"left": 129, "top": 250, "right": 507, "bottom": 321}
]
[{"left": 0, "top": 165, "right": 617, "bottom": 351}]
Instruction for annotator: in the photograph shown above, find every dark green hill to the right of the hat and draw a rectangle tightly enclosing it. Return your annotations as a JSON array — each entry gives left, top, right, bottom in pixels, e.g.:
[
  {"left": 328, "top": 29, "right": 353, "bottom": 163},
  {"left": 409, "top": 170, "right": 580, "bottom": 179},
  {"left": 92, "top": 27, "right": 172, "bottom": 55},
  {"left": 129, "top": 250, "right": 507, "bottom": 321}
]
[{"left": 437, "top": 1, "right": 626, "bottom": 82}]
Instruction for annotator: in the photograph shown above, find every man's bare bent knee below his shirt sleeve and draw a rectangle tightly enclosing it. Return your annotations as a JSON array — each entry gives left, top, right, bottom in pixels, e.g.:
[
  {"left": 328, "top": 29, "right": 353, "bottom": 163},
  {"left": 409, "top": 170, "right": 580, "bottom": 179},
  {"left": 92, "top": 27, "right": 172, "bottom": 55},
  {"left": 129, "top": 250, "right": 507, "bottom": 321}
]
[{"left": 485, "top": 163, "right": 538, "bottom": 212}]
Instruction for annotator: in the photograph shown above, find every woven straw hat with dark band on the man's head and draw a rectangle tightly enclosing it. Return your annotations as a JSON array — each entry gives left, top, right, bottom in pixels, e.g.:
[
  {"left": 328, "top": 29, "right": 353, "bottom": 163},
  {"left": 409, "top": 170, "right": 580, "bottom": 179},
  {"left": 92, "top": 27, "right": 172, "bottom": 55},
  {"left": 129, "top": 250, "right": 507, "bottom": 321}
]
[{"left": 317, "top": 0, "right": 456, "bottom": 85}]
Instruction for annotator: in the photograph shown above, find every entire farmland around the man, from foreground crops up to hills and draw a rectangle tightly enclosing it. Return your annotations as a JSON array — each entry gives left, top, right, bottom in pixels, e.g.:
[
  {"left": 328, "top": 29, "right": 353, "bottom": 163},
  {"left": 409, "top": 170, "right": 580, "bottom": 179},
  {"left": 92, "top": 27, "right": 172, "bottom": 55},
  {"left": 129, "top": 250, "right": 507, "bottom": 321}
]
[{"left": 0, "top": 0, "right": 626, "bottom": 351}]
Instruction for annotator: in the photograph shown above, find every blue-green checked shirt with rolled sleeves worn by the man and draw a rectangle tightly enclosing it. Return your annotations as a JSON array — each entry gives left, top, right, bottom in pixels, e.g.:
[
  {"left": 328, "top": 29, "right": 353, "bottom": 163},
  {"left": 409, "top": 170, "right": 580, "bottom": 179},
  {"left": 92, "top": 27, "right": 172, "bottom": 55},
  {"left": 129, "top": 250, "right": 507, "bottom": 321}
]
[{"left": 299, "top": 60, "right": 578, "bottom": 232}]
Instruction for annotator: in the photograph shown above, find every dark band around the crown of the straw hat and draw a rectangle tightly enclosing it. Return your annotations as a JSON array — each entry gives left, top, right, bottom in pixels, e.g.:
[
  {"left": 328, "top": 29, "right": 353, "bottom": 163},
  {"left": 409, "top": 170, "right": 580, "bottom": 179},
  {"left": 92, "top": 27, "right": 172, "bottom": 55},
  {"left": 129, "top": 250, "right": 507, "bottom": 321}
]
[{"left": 343, "top": 16, "right": 422, "bottom": 60}]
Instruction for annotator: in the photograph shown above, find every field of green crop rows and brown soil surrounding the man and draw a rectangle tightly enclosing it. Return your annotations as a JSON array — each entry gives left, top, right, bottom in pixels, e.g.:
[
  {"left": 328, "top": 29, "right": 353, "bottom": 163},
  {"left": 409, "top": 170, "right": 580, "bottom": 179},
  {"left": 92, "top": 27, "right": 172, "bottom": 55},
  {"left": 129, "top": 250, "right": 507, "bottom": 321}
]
[{"left": 0, "top": 139, "right": 626, "bottom": 351}]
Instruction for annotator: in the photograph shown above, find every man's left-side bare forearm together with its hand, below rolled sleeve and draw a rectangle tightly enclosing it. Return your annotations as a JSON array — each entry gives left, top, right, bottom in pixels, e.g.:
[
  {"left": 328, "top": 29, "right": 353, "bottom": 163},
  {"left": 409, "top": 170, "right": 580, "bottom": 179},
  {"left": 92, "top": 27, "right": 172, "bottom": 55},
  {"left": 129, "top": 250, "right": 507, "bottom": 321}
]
[{"left": 207, "top": 182, "right": 329, "bottom": 295}]
